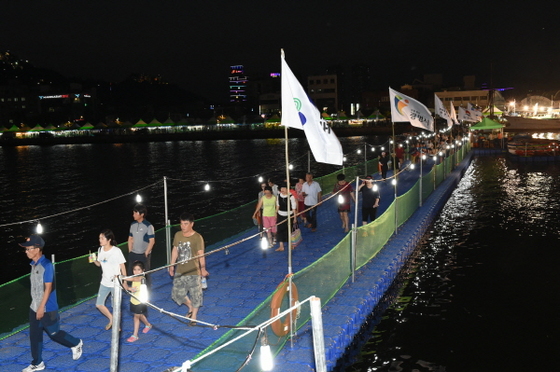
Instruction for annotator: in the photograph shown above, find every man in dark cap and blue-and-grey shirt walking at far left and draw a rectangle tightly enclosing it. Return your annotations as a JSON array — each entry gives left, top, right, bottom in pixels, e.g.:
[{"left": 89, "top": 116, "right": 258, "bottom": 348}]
[{"left": 20, "top": 235, "right": 83, "bottom": 372}]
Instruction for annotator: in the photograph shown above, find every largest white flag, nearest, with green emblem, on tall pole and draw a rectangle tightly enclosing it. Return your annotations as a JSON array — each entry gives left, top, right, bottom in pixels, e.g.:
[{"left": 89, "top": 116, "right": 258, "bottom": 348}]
[{"left": 281, "top": 51, "right": 344, "bottom": 165}]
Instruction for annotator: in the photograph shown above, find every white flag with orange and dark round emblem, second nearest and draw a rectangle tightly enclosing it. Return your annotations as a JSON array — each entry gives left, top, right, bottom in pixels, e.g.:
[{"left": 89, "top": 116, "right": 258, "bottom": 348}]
[{"left": 389, "top": 88, "right": 434, "bottom": 132}]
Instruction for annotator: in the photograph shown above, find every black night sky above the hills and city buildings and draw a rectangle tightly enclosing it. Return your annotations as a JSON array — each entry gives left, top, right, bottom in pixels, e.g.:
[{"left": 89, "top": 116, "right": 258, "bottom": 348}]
[{"left": 0, "top": 0, "right": 560, "bottom": 99}]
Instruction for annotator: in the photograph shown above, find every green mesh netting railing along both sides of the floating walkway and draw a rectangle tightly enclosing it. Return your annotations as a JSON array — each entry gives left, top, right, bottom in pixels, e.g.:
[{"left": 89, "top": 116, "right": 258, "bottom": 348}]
[{"left": 0, "top": 144, "right": 470, "bottom": 371}]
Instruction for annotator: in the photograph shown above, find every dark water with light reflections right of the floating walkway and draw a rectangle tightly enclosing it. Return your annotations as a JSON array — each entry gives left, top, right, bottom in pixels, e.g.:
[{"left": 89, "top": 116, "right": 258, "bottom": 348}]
[{"left": 340, "top": 157, "right": 560, "bottom": 372}]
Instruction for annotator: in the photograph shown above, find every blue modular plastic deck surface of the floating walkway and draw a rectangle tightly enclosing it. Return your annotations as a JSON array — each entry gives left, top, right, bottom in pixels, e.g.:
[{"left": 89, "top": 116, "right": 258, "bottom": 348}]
[{"left": 0, "top": 155, "right": 468, "bottom": 372}]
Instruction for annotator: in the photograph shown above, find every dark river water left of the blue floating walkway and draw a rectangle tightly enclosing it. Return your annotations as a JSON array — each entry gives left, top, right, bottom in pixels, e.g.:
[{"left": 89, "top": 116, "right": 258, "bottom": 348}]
[{"left": 0, "top": 136, "right": 386, "bottom": 283}]
